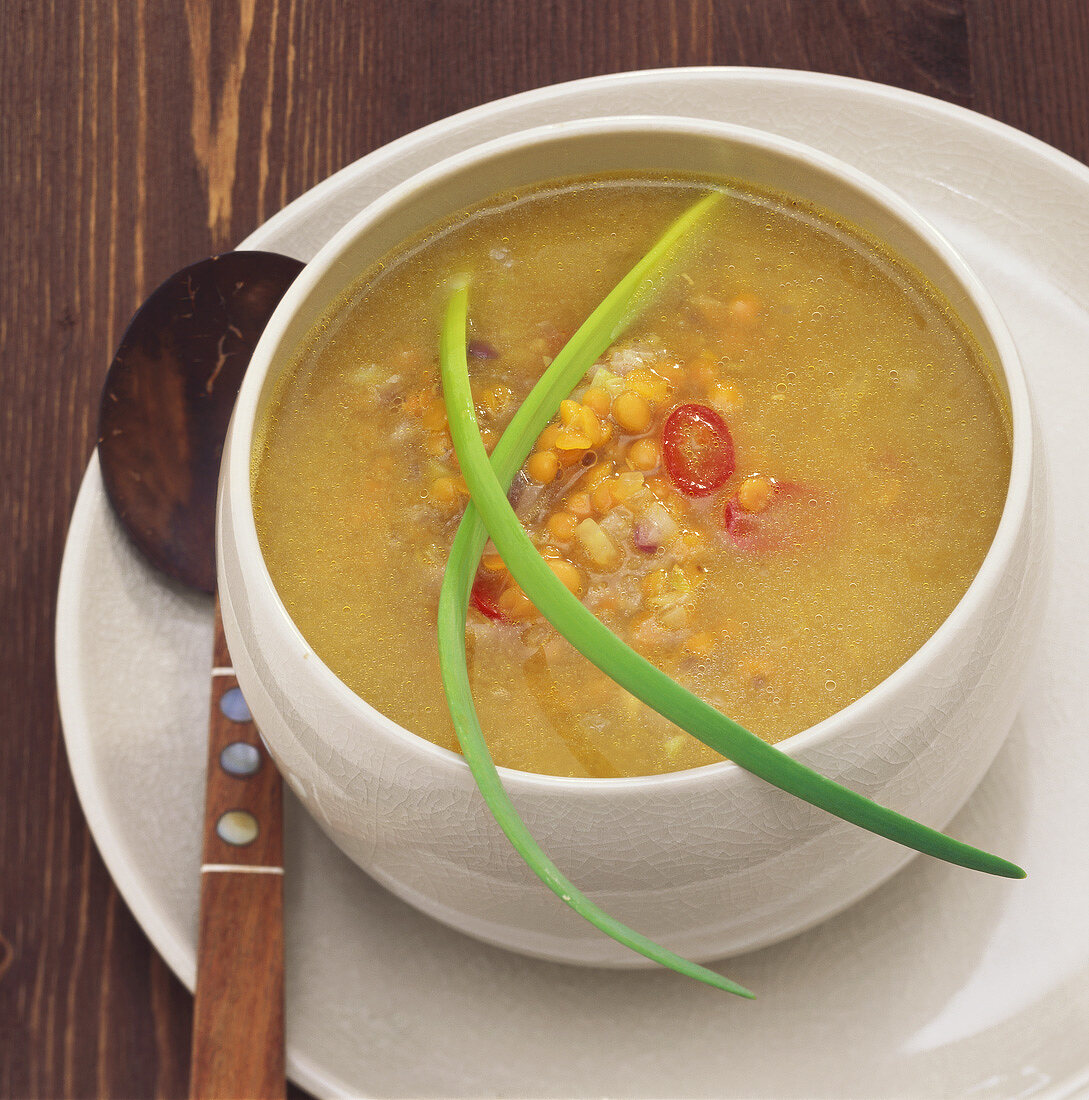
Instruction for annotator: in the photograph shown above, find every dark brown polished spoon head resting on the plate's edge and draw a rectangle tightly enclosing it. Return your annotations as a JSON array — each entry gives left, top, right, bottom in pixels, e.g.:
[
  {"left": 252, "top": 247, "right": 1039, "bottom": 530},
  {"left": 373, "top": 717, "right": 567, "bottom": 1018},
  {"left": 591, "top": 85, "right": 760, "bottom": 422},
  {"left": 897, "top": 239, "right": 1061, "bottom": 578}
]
[{"left": 98, "top": 252, "right": 303, "bottom": 592}]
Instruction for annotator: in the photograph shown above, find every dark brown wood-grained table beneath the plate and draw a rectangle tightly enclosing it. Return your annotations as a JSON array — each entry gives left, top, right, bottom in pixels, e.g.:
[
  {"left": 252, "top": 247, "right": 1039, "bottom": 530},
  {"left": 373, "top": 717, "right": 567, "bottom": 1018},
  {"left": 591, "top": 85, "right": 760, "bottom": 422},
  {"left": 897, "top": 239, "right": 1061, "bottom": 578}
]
[{"left": 0, "top": 0, "right": 1089, "bottom": 1097}]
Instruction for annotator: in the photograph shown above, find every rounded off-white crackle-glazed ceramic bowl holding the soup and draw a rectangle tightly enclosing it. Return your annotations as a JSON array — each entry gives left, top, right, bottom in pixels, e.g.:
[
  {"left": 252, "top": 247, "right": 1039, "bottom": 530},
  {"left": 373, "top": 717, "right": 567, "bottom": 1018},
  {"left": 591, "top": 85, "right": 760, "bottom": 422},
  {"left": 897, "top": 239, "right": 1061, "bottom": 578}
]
[{"left": 217, "top": 118, "right": 1047, "bottom": 966}]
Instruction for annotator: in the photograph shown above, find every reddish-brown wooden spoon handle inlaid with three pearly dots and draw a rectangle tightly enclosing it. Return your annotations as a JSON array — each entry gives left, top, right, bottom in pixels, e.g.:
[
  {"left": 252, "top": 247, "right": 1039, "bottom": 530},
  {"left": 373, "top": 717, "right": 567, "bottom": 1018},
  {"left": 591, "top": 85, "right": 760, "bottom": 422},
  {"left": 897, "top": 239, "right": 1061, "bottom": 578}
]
[{"left": 189, "top": 600, "right": 286, "bottom": 1100}]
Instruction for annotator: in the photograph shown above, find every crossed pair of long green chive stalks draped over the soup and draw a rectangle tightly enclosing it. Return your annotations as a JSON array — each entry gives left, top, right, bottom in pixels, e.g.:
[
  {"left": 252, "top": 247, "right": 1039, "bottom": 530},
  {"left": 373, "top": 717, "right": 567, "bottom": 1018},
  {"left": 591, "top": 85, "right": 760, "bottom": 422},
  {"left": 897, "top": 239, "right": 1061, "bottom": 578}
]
[{"left": 439, "top": 193, "right": 1025, "bottom": 988}]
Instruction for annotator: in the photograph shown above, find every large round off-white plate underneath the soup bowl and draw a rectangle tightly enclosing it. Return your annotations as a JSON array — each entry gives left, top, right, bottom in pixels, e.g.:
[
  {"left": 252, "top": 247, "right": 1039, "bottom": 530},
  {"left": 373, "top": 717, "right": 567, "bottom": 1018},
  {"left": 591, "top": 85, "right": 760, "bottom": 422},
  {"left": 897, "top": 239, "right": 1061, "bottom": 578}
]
[{"left": 57, "top": 69, "right": 1089, "bottom": 1097}]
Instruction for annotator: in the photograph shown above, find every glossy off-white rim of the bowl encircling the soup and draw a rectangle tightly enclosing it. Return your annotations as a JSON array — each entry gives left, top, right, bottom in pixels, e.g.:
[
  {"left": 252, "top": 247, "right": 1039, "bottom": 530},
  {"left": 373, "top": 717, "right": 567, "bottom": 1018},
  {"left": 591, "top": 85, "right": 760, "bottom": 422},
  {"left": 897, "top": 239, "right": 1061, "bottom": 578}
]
[{"left": 222, "top": 114, "right": 1035, "bottom": 795}]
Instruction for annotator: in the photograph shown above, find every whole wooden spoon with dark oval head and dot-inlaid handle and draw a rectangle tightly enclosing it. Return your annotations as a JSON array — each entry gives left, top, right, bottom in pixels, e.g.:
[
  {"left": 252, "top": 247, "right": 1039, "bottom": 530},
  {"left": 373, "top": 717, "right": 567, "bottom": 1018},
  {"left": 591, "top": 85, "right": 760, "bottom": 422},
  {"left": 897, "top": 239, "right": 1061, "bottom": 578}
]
[{"left": 98, "top": 252, "right": 303, "bottom": 1098}]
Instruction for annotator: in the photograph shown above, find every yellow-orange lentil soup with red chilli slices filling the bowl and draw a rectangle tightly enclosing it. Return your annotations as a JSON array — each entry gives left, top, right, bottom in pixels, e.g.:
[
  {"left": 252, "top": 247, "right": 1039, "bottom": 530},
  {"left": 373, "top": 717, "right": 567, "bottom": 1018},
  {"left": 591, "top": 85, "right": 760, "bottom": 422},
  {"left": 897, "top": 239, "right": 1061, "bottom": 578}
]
[{"left": 254, "top": 177, "right": 1010, "bottom": 777}]
